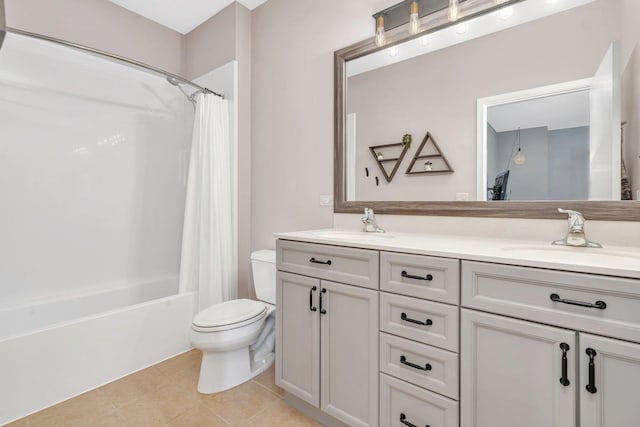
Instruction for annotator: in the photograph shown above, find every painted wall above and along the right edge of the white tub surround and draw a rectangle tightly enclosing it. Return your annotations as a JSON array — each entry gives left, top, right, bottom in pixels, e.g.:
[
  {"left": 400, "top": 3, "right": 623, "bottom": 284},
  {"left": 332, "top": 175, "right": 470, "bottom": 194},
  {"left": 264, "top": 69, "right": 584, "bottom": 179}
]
[{"left": 4, "top": 0, "right": 252, "bottom": 297}]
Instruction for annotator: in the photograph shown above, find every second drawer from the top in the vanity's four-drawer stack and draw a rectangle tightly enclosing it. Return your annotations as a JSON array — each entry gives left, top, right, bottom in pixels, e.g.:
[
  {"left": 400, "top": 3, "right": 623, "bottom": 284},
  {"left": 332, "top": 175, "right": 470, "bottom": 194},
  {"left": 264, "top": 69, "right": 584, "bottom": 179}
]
[{"left": 380, "top": 292, "right": 458, "bottom": 352}]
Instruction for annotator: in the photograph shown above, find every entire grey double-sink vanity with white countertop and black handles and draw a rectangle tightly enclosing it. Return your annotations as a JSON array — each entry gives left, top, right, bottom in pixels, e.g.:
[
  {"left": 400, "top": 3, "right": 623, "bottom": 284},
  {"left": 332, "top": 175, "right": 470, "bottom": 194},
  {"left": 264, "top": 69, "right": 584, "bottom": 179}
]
[{"left": 276, "top": 229, "right": 640, "bottom": 427}]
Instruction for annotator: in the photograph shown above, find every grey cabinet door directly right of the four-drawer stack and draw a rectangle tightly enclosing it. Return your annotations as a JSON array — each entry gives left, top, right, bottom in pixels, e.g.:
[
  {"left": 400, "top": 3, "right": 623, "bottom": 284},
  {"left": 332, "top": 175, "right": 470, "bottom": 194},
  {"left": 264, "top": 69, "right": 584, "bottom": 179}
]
[{"left": 460, "top": 309, "right": 577, "bottom": 427}]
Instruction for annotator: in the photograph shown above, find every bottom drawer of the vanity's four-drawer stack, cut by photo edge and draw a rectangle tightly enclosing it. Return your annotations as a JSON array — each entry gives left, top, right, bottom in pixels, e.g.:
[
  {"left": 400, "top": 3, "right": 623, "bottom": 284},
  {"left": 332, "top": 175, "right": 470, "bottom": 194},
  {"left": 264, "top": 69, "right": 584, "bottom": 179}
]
[{"left": 380, "top": 374, "right": 458, "bottom": 427}]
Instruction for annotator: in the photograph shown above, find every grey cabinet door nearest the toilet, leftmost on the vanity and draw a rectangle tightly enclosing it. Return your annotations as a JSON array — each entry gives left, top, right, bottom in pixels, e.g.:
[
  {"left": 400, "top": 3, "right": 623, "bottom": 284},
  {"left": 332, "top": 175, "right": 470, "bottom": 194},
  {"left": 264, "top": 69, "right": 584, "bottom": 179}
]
[{"left": 276, "top": 271, "right": 320, "bottom": 406}]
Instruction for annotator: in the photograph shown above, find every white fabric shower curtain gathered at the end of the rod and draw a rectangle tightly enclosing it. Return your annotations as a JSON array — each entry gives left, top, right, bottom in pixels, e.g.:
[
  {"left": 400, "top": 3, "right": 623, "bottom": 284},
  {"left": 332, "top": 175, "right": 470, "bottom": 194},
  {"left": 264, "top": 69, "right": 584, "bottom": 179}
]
[{"left": 179, "top": 94, "right": 237, "bottom": 310}]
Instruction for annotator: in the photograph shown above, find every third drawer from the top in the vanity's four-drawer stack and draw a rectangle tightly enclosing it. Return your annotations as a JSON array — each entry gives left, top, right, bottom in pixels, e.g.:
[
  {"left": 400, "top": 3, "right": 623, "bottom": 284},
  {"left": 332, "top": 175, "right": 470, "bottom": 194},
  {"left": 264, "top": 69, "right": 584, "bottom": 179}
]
[{"left": 380, "top": 332, "right": 458, "bottom": 400}]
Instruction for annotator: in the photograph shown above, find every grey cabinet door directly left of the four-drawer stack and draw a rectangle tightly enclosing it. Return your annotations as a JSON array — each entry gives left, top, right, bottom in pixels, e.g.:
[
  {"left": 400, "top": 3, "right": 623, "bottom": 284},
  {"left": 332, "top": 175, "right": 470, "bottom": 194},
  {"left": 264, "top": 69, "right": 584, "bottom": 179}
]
[{"left": 320, "top": 281, "right": 378, "bottom": 426}]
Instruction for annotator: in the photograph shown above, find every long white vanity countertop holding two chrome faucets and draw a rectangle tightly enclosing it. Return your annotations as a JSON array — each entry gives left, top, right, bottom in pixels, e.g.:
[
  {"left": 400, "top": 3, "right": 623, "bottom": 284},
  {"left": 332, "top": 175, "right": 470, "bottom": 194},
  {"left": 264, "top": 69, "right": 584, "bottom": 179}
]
[{"left": 275, "top": 229, "right": 640, "bottom": 279}]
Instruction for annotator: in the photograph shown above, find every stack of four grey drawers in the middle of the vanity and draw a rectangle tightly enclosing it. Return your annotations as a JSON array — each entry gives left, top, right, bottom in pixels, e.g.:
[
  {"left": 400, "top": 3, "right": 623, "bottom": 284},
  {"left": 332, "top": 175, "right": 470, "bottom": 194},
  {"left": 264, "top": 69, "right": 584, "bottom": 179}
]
[{"left": 380, "top": 251, "right": 460, "bottom": 427}]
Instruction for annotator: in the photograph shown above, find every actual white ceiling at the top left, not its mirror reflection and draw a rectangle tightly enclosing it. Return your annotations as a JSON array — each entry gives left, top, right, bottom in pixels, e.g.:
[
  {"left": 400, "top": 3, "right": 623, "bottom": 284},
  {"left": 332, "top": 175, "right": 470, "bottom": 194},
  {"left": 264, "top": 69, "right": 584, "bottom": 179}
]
[{"left": 109, "top": 0, "right": 267, "bottom": 34}]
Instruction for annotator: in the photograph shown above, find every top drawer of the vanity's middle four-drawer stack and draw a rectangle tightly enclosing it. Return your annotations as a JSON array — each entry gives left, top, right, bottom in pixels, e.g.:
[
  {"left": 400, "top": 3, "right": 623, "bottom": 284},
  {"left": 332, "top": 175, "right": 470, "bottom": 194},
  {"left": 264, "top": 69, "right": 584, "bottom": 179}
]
[{"left": 380, "top": 252, "right": 460, "bottom": 304}]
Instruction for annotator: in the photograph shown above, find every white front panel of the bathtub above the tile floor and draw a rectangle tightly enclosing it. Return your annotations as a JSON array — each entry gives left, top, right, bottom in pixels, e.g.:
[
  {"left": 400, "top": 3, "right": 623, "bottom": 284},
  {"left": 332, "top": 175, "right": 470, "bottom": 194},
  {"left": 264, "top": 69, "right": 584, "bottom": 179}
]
[{"left": 0, "top": 293, "right": 196, "bottom": 425}]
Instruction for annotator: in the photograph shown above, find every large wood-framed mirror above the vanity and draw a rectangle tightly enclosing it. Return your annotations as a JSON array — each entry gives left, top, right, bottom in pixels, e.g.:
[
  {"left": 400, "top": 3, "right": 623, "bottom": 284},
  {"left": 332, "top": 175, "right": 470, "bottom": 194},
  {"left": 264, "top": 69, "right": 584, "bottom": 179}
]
[{"left": 335, "top": 0, "right": 640, "bottom": 219}]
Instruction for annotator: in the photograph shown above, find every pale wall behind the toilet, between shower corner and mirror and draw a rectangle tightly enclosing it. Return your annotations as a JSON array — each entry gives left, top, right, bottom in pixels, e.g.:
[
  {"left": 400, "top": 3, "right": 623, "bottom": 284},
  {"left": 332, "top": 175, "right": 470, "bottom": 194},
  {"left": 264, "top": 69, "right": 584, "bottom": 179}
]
[{"left": 251, "top": 0, "right": 380, "bottom": 254}]
